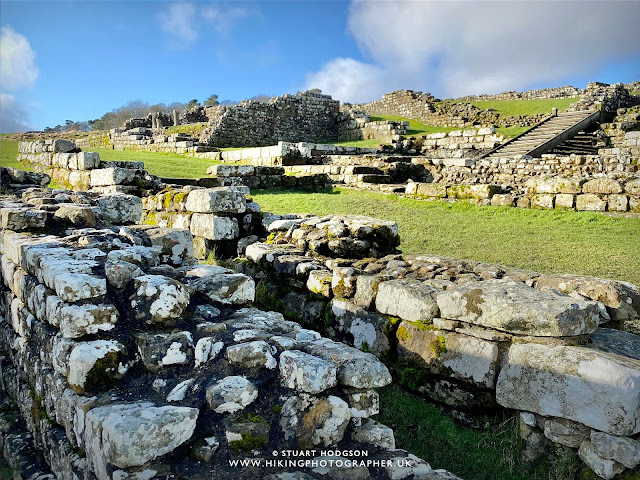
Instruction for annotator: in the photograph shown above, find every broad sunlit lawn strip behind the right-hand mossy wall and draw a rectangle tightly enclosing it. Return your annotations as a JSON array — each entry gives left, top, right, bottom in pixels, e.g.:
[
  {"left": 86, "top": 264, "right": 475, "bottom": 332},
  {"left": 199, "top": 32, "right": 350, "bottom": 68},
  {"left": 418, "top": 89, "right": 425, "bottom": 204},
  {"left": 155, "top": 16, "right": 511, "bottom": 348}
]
[{"left": 254, "top": 189, "right": 640, "bottom": 284}]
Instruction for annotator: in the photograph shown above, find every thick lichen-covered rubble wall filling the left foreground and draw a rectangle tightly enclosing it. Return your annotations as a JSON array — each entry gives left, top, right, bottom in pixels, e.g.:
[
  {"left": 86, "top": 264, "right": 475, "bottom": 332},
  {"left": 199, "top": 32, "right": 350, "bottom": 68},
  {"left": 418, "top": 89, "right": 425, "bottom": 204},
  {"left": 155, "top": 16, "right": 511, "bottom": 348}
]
[{"left": 0, "top": 181, "right": 457, "bottom": 480}]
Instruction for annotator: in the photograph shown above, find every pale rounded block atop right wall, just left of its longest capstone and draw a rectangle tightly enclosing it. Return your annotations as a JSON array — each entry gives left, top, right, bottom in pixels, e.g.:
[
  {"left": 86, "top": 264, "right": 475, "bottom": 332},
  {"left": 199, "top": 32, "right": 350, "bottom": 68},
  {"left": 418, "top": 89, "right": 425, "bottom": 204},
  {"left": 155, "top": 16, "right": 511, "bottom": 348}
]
[{"left": 375, "top": 280, "right": 439, "bottom": 322}]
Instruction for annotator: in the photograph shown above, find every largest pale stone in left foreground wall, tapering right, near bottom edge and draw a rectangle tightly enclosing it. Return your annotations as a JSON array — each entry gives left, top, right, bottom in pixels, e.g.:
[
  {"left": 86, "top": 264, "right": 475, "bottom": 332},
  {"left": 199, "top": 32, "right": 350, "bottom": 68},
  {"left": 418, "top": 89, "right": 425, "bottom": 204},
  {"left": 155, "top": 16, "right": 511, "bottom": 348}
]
[{"left": 84, "top": 402, "right": 198, "bottom": 478}]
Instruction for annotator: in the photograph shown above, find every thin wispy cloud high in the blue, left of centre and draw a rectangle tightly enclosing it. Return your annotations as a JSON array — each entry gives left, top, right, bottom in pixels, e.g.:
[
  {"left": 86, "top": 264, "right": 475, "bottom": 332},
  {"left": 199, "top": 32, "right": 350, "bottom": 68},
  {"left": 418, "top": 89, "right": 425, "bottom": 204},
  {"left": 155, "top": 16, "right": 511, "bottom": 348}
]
[{"left": 156, "top": 2, "right": 251, "bottom": 48}]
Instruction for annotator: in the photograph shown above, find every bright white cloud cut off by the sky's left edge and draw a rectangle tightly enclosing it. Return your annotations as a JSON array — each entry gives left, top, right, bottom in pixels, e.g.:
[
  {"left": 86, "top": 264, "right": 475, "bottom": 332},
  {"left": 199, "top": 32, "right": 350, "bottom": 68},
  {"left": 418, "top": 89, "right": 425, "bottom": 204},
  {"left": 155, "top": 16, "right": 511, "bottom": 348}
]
[{"left": 0, "top": 26, "right": 40, "bottom": 90}]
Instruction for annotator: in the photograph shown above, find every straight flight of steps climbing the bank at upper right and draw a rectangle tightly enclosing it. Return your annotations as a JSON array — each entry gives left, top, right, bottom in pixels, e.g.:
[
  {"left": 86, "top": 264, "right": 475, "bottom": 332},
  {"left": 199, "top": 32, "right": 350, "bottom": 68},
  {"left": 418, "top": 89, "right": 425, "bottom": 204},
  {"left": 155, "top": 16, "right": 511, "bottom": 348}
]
[{"left": 483, "top": 110, "right": 600, "bottom": 158}]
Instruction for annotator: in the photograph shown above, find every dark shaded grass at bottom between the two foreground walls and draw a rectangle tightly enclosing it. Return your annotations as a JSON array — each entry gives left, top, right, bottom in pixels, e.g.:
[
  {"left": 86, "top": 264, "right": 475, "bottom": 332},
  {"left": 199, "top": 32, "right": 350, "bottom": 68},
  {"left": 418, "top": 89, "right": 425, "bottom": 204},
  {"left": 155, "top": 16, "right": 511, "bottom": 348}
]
[{"left": 377, "top": 385, "right": 580, "bottom": 480}]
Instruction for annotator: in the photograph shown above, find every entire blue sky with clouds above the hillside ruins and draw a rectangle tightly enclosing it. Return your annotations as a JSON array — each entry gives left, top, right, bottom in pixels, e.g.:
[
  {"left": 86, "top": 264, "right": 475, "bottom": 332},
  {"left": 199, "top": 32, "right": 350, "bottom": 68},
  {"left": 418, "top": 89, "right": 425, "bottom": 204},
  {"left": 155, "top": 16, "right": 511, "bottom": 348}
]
[{"left": 0, "top": 0, "right": 640, "bottom": 131}]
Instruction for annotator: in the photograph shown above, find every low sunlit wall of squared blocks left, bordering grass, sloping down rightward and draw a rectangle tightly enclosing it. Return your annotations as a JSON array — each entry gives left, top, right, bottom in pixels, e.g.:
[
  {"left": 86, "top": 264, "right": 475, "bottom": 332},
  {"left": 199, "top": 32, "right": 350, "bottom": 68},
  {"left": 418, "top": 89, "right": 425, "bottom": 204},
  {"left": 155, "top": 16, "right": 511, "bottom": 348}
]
[{"left": 18, "top": 140, "right": 161, "bottom": 194}]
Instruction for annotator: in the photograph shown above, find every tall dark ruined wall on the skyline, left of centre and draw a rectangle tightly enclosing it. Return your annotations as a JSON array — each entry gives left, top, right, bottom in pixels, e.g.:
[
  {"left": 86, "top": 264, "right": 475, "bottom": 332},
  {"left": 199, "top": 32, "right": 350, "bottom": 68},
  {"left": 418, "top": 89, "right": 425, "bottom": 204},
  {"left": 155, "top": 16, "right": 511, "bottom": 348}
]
[{"left": 200, "top": 92, "right": 340, "bottom": 147}]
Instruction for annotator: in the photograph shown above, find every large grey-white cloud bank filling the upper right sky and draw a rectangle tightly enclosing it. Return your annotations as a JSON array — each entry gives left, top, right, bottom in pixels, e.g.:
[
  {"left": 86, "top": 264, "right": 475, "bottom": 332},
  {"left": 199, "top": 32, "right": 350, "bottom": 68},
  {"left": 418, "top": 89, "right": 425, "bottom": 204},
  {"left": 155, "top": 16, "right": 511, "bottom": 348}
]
[{"left": 307, "top": 1, "right": 640, "bottom": 101}]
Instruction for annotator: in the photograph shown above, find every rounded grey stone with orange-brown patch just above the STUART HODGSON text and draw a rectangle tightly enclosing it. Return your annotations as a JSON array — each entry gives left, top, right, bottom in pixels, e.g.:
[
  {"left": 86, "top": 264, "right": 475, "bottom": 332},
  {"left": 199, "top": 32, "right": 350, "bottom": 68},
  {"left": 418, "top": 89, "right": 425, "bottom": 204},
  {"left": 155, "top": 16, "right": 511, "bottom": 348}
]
[{"left": 280, "top": 394, "right": 351, "bottom": 448}]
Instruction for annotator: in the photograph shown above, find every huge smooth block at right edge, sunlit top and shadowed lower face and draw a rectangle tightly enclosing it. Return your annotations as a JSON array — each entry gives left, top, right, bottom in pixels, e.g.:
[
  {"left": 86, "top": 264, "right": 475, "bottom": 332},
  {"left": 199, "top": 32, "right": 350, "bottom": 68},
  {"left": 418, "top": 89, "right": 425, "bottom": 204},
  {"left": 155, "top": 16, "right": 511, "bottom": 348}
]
[{"left": 496, "top": 344, "right": 640, "bottom": 436}]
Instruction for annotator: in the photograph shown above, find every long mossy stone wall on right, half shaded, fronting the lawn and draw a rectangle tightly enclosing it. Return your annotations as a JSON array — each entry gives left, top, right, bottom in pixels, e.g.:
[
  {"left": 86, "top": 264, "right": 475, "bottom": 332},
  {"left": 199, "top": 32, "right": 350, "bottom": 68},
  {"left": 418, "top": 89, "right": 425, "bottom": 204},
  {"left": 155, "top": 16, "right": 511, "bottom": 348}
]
[{"left": 236, "top": 215, "right": 640, "bottom": 479}]
